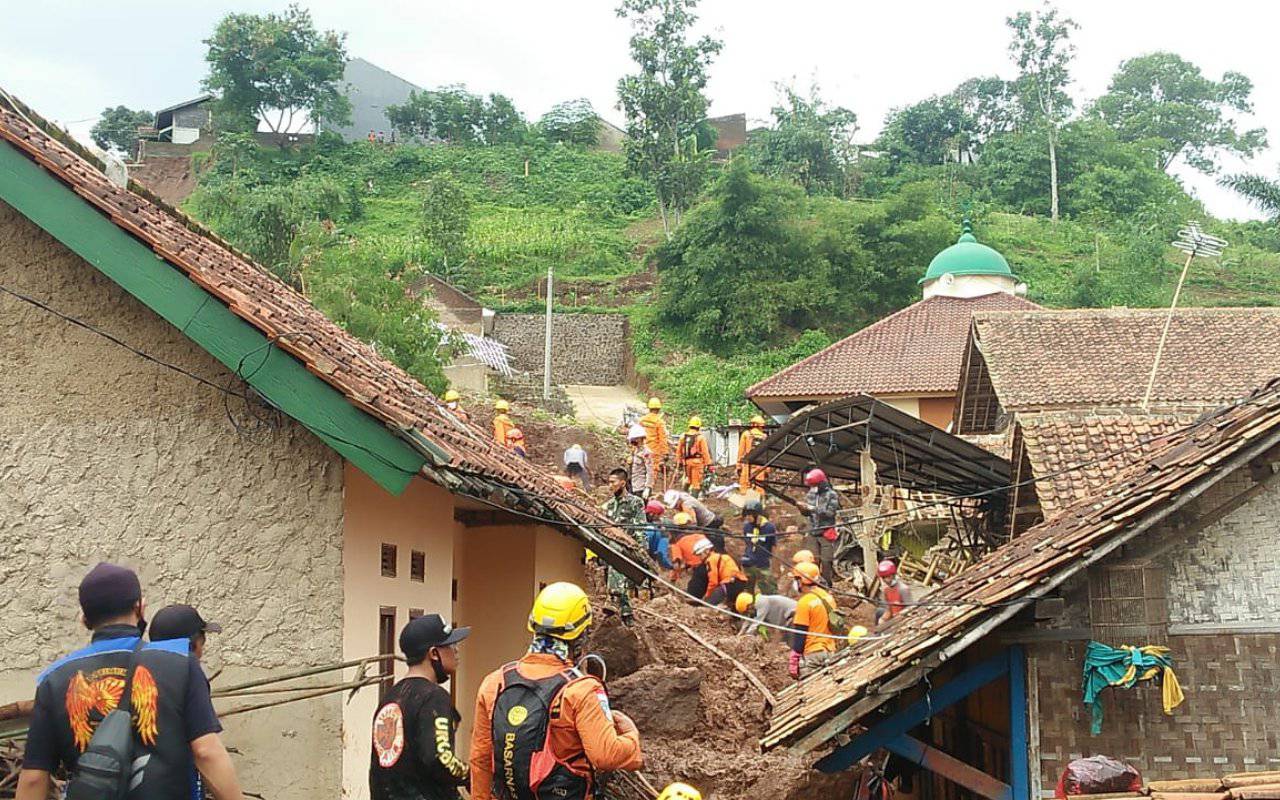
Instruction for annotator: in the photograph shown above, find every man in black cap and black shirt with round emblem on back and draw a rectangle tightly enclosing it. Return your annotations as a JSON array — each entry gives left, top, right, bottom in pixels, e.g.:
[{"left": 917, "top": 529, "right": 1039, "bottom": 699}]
[{"left": 369, "top": 614, "right": 471, "bottom": 800}]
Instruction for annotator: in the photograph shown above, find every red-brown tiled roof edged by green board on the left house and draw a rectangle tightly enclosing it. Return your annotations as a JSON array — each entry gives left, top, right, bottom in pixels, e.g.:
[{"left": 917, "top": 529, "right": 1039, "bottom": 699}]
[{"left": 0, "top": 93, "right": 645, "bottom": 568}]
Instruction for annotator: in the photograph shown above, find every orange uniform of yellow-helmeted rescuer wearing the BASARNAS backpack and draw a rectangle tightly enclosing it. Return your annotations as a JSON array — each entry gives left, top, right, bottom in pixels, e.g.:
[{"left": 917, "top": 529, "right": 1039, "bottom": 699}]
[{"left": 471, "top": 653, "right": 644, "bottom": 800}]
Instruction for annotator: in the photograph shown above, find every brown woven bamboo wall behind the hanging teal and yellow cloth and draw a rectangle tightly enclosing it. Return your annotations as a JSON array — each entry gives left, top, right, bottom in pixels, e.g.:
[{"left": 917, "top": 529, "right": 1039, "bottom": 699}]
[{"left": 1028, "top": 634, "right": 1280, "bottom": 790}]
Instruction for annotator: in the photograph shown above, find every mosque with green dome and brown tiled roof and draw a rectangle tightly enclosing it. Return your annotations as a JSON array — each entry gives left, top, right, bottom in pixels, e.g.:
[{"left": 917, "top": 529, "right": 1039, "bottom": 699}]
[{"left": 746, "top": 224, "right": 1039, "bottom": 429}]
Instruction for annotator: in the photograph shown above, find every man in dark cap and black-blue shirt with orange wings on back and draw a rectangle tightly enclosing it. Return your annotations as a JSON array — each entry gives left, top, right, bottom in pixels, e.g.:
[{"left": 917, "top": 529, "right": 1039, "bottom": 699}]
[{"left": 17, "top": 563, "right": 243, "bottom": 800}]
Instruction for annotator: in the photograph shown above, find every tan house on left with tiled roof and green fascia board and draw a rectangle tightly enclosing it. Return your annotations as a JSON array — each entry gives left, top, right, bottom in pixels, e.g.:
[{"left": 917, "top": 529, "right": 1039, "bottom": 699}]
[{"left": 0, "top": 90, "right": 639, "bottom": 799}]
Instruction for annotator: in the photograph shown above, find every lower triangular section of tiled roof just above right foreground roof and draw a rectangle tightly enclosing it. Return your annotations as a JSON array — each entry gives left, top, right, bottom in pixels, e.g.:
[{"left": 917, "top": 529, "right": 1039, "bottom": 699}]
[{"left": 1018, "top": 411, "right": 1196, "bottom": 518}]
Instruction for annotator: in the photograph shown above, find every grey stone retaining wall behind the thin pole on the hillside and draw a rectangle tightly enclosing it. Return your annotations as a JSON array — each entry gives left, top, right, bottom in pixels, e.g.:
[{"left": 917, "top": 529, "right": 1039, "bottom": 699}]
[{"left": 493, "top": 314, "right": 631, "bottom": 387}]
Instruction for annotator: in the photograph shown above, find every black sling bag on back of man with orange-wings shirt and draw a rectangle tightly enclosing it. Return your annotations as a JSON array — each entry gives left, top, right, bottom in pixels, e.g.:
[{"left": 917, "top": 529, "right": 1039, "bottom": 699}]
[{"left": 65, "top": 636, "right": 150, "bottom": 800}]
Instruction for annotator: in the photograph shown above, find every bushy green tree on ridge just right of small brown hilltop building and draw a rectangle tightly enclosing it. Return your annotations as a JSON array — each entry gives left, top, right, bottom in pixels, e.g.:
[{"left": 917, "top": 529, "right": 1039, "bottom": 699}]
[{"left": 748, "top": 86, "right": 858, "bottom": 196}]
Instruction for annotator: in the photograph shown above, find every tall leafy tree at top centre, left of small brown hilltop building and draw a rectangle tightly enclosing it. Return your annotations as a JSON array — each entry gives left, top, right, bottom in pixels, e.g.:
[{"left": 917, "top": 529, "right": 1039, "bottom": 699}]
[{"left": 617, "top": 0, "right": 722, "bottom": 238}]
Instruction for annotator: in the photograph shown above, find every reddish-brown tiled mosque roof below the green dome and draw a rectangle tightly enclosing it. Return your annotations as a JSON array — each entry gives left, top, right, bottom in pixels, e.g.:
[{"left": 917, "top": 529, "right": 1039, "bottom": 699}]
[{"left": 746, "top": 292, "right": 1039, "bottom": 399}]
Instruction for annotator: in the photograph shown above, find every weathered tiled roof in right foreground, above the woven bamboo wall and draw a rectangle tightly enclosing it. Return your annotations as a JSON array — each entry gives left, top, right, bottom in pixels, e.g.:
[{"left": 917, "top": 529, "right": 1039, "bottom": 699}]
[{"left": 762, "top": 379, "right": 1280, "bottom": 748}]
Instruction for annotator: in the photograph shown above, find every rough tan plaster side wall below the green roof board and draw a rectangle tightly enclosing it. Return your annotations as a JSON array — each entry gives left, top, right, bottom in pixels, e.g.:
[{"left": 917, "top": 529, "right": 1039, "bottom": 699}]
[{"left": 0, "top": 204, "right": 343, "bottom": 800}]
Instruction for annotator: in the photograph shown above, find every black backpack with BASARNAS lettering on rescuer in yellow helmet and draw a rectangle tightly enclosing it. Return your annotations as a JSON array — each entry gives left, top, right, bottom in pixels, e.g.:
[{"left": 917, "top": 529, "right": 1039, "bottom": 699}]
[{"left": 493, "top": 664, "right": 591, "bottom": 800}]
